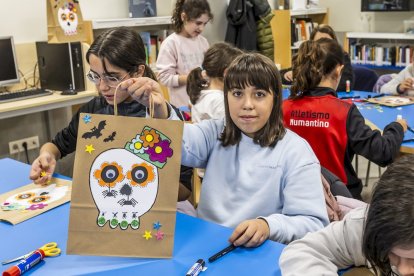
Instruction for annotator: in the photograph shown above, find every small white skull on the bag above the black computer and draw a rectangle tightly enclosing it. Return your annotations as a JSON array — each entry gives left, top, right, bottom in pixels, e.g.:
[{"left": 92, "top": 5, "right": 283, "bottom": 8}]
[{"left": 55, "top": 0, "right": 78, "bottom": 36}]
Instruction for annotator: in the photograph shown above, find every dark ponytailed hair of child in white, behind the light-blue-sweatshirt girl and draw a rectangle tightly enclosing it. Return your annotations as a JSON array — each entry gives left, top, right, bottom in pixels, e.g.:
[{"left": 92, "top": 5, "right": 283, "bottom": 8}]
[{"left": 187, "top": 42, "right": 243, "bottom": 104}]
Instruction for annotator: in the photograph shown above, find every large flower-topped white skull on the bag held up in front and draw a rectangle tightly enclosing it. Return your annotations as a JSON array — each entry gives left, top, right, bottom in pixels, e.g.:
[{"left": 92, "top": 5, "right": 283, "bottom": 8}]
[{"left": 89, "top": 126, "right": 173, "bottom": 230}]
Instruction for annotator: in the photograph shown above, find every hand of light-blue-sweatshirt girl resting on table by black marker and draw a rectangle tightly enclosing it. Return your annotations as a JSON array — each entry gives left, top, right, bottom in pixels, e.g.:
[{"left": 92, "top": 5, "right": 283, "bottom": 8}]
[{"left": 229, "top": 219, "right": 270, "bottom": 247}]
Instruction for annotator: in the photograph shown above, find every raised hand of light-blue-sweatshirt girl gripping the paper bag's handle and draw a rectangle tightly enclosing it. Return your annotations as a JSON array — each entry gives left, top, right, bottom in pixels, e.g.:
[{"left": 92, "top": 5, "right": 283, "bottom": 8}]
[{"left": 119, "top": 77, "right": 168, "bottom": 119}]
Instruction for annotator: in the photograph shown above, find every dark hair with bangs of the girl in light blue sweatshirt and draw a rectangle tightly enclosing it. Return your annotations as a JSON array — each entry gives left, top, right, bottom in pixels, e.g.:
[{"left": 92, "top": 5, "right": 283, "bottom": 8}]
[{"left": 220, "top": 53, "right": 286, "bottom": 147}]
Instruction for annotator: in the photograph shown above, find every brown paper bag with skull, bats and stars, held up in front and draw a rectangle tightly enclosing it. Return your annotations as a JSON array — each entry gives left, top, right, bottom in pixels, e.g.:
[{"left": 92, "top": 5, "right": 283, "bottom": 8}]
[{"left": 67, "top": 113, "right": 183, "bottom": 258}]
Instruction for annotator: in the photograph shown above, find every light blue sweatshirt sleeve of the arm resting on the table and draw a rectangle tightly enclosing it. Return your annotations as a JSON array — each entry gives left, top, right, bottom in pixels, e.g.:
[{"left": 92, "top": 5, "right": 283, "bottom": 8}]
[{"left": 263, "top": 136, "right": 329, "bottom": 243}]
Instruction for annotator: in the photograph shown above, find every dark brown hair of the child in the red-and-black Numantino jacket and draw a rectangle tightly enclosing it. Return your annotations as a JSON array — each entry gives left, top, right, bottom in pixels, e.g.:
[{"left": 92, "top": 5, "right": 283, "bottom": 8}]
[{"left": 290, "top": 38, "right": 344, "bottom": 99}]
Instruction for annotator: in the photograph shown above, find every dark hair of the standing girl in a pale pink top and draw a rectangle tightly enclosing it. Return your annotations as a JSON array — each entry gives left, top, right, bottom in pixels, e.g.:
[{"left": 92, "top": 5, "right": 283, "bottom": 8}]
[{"left": 171, "top": 0, "right": 213, "bottom": 33}]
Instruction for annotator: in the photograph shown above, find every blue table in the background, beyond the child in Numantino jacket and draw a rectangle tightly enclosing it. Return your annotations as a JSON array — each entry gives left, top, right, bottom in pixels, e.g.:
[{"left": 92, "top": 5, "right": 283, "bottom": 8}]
[{"left": 282, "top": 89, "right": 414, "bottom": 153}]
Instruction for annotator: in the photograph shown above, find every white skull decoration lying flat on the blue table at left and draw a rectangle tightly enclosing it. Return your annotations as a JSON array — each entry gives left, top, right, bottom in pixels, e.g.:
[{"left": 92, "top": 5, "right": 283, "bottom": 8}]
[{"left": 1, "top": 184, "right": 69, "bottom": 211}]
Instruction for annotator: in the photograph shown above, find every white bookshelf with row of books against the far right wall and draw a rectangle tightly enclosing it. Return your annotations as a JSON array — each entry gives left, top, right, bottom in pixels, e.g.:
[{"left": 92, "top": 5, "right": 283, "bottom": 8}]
[{"left": 344, "top": 32, "right": 414, "bottom": 72}]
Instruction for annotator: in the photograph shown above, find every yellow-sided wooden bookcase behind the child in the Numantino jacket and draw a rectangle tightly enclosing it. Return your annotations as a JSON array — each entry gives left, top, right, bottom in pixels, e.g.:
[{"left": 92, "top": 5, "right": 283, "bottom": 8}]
[{"left": 270, "top": 8, "right": 329, "bottom": 68}]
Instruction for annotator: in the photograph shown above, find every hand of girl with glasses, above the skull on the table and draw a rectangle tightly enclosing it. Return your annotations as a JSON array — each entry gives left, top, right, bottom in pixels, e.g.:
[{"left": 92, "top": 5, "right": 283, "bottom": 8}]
[{"left": 30, "top": 151, "right": 56, "bottom": 184}]
